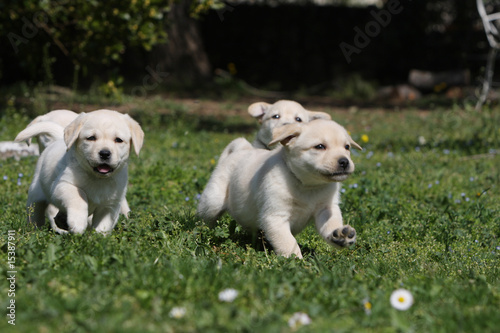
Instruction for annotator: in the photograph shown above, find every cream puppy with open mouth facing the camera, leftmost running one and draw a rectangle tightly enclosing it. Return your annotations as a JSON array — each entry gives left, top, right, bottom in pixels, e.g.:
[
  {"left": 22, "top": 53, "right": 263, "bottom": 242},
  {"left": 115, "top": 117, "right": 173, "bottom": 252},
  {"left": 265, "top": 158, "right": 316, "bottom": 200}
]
[{"left": 16, "top": 110, "right": 144, "bottom": 234}]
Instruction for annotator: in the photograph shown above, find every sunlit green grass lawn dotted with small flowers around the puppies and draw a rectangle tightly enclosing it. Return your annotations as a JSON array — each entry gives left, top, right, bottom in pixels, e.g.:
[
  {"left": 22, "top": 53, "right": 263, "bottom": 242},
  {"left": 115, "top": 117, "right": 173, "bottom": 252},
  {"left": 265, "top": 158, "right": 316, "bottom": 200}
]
[{"left": 0, "top": 96, "right": 500, "bottom": 332}]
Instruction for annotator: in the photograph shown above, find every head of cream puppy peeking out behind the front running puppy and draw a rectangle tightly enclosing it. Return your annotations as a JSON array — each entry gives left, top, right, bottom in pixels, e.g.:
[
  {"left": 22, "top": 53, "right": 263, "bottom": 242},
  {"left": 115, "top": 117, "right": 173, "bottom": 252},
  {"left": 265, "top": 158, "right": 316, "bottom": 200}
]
[{"left": 248, "top": 100, "right": 332, "bottom": 149}]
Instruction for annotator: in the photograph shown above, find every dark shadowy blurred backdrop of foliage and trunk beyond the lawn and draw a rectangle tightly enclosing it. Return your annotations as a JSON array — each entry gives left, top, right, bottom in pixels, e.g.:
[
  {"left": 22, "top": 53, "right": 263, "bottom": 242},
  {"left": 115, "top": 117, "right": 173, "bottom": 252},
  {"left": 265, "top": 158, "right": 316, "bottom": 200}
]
[{"left": 0, "top": 0, "right": 488, "bottom": 98}]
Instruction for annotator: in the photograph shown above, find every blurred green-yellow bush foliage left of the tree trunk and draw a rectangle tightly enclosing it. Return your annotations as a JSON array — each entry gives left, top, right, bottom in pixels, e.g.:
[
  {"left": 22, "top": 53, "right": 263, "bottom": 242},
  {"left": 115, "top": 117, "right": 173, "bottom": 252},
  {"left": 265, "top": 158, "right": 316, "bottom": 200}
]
[{"left": 0, "top": 0, "right": 221, "bottom": 87}]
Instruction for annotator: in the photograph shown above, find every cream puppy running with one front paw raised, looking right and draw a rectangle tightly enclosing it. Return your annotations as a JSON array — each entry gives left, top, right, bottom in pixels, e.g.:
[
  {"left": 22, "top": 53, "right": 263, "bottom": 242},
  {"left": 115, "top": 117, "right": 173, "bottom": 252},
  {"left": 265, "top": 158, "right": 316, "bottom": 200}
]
[{"left": 197, "top": 120, "right": 362, "bottom": 258}]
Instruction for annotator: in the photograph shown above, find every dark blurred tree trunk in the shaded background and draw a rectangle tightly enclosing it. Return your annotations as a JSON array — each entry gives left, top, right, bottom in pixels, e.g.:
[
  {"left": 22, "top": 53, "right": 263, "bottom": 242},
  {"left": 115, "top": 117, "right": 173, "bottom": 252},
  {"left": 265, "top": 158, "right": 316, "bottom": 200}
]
[{"left": 150, "top": 0, "right": 212, "bottom": 85}]
